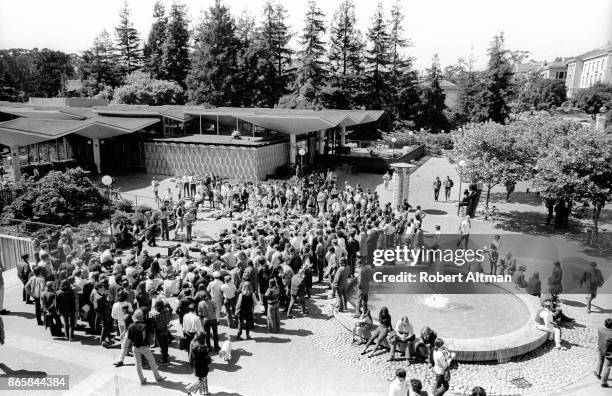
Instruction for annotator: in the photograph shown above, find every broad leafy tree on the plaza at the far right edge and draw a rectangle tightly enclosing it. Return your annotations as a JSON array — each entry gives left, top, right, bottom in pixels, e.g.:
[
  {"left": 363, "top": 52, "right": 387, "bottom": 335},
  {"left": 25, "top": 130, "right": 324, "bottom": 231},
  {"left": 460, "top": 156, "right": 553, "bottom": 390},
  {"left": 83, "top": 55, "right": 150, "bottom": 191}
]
[{"left": 533, "top": 127, "right": 612, "bottom": 232}]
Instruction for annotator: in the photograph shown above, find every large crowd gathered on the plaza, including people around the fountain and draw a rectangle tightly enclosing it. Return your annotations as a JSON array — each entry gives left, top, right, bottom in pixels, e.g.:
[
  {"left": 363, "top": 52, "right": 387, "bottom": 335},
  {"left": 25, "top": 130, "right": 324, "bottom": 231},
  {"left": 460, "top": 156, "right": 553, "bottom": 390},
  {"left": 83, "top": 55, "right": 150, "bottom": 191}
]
[{"left": 2, "top": 168, "right": 598, "bottom": 394}]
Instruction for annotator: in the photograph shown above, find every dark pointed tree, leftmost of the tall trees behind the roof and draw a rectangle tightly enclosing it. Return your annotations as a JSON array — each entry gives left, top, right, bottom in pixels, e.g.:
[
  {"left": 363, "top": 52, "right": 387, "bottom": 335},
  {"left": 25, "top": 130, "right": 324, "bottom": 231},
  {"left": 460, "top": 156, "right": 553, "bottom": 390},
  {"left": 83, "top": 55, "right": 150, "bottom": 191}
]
[{"left": 80, "top": 30, "right": 122, "bottom": 96}]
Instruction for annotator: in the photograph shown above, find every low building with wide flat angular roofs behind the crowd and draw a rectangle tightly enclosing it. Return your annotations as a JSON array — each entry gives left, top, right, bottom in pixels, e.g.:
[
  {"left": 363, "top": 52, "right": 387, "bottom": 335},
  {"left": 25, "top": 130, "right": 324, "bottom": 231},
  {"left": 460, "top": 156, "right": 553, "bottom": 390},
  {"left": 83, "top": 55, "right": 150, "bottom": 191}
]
[{"left": 0, "top": 98, "right": 383, "bottom": 180}]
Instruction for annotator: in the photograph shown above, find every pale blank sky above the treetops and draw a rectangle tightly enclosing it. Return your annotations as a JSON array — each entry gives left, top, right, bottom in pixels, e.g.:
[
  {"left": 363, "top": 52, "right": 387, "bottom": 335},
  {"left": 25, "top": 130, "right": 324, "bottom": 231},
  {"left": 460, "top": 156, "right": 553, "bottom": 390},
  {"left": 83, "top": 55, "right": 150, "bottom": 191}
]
[{"left": 0, "top": 0, "right": 612, "bottom": 71}]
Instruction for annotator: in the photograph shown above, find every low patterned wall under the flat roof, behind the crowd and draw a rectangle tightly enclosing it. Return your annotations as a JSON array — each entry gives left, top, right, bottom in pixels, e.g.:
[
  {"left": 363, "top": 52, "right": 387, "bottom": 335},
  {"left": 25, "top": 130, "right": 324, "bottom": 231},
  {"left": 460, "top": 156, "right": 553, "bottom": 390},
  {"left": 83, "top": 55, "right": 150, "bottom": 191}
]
[{"left": 144, "top": 142, "right": 289, "bottom": 180}]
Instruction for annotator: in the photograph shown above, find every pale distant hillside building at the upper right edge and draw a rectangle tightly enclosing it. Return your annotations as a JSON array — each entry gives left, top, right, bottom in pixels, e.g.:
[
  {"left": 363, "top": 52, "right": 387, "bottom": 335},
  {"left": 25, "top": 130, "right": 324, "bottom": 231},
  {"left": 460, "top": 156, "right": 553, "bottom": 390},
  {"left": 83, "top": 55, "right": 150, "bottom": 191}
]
[{"left": 565, "top": 44, "right": 612, "bottom": 98}]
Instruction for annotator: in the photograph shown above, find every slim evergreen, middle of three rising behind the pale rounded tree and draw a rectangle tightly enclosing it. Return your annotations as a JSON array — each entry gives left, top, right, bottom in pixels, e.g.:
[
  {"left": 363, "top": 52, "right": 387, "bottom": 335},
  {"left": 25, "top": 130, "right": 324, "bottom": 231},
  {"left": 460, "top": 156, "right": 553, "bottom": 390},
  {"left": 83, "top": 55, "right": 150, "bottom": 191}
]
[{"left": 143, "top": 0, "right": 168, "bottom": 79}]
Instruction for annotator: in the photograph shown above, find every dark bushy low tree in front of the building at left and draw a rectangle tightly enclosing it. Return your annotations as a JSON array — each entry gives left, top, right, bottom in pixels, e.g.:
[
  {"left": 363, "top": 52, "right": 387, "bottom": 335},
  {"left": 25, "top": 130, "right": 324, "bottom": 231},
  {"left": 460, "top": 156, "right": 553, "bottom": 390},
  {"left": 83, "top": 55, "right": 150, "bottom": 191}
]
[{"left": 2, "top": 168, "right": 108, "bottom": 224}]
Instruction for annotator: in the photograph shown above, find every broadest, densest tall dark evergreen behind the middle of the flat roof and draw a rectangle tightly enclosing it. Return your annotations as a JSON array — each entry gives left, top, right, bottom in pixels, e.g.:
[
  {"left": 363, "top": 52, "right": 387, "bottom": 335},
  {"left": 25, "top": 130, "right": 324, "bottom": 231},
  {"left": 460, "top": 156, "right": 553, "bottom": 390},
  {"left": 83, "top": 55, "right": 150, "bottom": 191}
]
[{"left": 186, "top": 0, "right": 239, "bottom": 106}]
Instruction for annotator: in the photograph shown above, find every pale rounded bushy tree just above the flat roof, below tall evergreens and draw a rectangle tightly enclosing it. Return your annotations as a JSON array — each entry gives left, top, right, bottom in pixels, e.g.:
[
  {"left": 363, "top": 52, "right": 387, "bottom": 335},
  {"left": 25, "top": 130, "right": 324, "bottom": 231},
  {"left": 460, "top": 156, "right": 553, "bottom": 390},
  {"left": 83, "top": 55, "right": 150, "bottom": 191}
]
[{"left": 113, "top": 71, "right": 183, "bottom": 106}]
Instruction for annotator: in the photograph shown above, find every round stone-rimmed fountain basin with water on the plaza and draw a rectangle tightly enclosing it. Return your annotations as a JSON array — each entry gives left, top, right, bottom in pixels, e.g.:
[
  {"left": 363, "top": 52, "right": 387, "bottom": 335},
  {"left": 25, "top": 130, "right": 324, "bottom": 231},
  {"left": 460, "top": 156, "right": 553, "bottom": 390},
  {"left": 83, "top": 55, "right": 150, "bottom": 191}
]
[{"left": 369, "top": 284, "right": 547, "bottom": 361}]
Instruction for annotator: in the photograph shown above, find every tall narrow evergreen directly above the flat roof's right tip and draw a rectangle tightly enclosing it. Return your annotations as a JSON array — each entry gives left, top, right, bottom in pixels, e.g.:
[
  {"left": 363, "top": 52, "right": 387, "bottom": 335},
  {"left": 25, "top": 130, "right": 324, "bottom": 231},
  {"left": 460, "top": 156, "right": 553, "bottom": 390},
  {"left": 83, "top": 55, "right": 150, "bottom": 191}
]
[{"left": 364, "top": 2, "right": 392, "bottom": 109}]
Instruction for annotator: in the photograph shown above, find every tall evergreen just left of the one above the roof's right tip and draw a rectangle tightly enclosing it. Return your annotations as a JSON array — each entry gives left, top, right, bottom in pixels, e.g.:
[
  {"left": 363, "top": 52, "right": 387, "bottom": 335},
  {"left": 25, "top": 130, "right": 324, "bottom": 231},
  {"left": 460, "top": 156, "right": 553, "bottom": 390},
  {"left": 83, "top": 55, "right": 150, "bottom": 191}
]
[{"left": 325, "top": 0, "right": 364, "bottom": 109}]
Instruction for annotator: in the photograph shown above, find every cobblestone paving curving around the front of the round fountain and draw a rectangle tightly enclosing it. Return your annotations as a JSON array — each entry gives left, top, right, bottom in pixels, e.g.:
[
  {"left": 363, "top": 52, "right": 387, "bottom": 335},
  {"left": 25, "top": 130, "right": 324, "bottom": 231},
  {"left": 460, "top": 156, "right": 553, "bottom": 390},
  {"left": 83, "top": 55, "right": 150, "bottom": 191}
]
[{"left": 296, "top": 288, "right": 597, "bottom": 396}]
